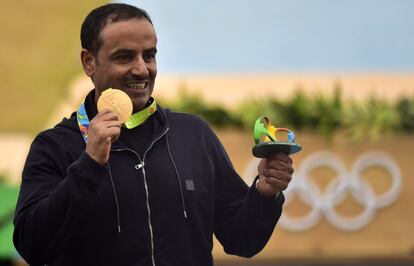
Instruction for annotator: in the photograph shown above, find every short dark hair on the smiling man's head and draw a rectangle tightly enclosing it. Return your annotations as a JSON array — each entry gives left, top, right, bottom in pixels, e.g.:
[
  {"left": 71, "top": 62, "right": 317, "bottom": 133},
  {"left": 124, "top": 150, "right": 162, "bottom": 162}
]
[{"left": 80, "top": 3, "right": 152, "bottom": 55}]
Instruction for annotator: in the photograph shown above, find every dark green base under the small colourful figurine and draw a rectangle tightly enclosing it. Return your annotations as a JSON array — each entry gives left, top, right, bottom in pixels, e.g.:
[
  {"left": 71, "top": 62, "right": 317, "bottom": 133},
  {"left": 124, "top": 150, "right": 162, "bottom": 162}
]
[{"left": 253, "top": 141, "right": 302, "bottom": 158}]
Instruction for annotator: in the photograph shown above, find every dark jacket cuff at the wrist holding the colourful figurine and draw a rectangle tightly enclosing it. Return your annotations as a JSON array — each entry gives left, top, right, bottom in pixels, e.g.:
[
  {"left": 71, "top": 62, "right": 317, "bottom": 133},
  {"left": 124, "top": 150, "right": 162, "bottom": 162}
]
[{"left": 247, "top": 176, "right": 285, "bottom": 219}]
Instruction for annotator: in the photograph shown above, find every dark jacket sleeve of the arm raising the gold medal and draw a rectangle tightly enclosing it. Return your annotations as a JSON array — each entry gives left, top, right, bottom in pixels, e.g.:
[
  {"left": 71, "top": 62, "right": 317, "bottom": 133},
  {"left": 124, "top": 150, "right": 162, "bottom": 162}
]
[{"left": 13, "top": 133, "right": 108, "bottom": 265}]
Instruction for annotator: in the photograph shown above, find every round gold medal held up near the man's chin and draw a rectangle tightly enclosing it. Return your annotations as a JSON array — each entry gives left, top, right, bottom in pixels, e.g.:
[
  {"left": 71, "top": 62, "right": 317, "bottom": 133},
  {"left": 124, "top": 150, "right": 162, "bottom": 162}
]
[{"left": 97, "top": 88, "right": 132, "bottom": 123}]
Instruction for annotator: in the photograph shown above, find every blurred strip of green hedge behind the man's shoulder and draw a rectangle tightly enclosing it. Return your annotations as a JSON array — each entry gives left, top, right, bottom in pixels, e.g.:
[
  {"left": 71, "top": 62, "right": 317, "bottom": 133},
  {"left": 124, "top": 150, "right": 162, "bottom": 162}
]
[{"left": 160, "top": 84, "right": 414, "bottom": 141}]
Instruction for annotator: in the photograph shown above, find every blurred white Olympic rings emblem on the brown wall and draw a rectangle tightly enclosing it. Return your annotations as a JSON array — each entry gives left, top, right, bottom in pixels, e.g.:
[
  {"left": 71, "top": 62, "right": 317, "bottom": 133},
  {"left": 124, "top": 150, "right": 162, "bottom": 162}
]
[{"left": 243, "top": 152, "right": 401, "bottom": 231}]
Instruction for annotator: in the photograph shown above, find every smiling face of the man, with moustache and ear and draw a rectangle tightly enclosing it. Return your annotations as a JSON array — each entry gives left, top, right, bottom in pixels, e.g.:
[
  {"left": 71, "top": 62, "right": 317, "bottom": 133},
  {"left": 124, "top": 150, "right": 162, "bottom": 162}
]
[{"left": 81, "top": 19, "right": 157, "bottom": 112}]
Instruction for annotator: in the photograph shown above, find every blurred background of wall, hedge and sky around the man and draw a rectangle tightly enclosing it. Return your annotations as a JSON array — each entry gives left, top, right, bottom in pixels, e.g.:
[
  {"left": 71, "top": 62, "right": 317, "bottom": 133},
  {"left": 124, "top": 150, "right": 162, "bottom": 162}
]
[{"left": 0, "top": 0, "right": 414, "bottom": 266}]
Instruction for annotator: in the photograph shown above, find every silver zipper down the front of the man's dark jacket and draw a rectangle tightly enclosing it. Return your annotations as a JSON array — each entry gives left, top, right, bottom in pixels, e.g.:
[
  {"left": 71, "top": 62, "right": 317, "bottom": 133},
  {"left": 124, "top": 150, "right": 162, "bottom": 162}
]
[{"left": 113, "top": 127, "right": 169, "bottom": 266}]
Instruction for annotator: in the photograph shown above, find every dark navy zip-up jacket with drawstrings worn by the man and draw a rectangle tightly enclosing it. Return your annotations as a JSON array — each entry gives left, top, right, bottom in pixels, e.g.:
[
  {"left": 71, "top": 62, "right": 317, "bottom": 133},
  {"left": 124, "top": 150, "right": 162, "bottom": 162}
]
[{"left": 14, "top": 90, "right": 284, "bottom": 266}]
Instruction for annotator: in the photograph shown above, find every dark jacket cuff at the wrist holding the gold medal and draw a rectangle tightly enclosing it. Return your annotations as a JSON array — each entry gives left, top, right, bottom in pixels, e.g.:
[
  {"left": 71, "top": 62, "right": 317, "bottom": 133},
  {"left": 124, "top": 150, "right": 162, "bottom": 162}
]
[{"left": 70, "top": 152, "right": 108, "bottom": 184}]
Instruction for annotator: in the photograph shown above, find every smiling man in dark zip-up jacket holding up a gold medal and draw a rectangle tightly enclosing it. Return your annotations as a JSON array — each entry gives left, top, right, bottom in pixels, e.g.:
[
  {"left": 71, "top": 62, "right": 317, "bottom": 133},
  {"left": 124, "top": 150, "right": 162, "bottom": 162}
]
[{"left": 14, "top": 4, "right": 293, "bottom": 266}]
